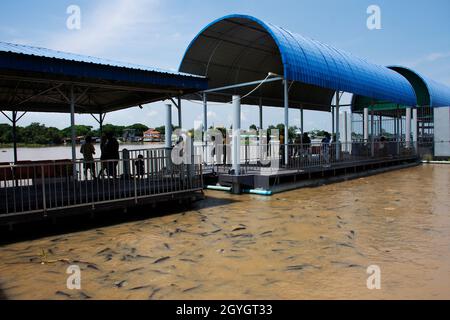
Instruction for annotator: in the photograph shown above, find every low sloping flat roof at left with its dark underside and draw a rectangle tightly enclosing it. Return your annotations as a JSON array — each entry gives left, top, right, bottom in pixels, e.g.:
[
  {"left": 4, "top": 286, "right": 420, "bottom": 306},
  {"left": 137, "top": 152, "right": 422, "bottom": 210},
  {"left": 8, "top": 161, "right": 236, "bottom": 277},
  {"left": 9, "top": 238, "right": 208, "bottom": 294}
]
[{"left": 0, "top": 42, "right": 207, "bottom": 114}]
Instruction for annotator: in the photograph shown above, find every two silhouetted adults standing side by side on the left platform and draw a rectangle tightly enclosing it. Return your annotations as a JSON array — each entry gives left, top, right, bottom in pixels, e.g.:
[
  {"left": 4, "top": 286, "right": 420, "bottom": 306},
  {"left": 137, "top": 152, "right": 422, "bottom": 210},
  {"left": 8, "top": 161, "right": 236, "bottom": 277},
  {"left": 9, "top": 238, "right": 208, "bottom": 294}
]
[{"left": 80, "top": 132, "right": 120, "bottom": 179}]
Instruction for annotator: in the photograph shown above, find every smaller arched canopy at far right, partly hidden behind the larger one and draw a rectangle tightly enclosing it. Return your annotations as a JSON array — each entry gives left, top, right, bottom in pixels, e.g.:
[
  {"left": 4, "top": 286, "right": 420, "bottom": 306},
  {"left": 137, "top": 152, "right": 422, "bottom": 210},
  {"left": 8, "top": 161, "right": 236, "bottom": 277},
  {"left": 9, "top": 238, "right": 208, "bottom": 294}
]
[{"left": 352, "top": 66, "right": 450, "bottom": 115}]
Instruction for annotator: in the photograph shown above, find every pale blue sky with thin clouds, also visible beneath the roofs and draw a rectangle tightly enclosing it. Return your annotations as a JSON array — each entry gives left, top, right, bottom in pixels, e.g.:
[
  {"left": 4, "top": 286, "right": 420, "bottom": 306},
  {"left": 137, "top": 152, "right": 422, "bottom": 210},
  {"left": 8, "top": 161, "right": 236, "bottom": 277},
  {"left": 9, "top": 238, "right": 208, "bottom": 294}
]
[{"left": 0, "top": 0, "right": 450, "bottom": 130}]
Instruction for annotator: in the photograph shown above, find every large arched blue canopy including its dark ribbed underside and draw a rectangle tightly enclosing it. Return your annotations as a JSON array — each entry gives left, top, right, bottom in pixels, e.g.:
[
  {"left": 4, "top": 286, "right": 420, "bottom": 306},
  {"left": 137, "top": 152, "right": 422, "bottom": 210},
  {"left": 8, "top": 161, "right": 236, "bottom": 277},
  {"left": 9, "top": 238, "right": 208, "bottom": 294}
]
[{"left": 180, "top": 15, "right": 416, "bottom": 111}]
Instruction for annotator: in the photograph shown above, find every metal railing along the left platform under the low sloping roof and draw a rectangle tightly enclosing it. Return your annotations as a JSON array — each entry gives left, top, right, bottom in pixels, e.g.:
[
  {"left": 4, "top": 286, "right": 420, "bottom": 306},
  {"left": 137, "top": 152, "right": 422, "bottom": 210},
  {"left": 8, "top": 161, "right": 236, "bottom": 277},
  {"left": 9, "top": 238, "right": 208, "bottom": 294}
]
[{"left": 0, "top": 149, "right": 203, "bottom": 215}]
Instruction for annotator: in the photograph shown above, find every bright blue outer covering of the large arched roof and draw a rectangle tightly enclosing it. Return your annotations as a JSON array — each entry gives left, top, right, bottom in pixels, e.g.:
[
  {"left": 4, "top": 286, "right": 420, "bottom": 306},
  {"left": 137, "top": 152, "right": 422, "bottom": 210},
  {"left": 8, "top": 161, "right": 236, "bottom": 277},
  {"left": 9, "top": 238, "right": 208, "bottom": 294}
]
[{"left": 183, "top": 14, "right": 416, "bottom": 106}]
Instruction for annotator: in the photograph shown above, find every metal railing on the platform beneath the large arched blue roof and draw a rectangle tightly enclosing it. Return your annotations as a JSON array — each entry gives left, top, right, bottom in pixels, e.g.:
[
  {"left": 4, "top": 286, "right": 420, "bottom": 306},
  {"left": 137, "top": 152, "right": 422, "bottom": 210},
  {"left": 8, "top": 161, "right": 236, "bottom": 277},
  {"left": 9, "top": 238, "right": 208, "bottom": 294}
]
[{"left": 194, "top": 141, "right": 417, "bottom": 174}]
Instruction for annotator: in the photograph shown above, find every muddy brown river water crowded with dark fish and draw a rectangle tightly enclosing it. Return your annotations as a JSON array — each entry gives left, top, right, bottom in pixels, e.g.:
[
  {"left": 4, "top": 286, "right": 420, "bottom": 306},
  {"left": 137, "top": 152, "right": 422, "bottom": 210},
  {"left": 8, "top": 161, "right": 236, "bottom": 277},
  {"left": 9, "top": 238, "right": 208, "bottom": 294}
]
[{"left": 0, "top": 165, "right": 450, "bottom": 299}]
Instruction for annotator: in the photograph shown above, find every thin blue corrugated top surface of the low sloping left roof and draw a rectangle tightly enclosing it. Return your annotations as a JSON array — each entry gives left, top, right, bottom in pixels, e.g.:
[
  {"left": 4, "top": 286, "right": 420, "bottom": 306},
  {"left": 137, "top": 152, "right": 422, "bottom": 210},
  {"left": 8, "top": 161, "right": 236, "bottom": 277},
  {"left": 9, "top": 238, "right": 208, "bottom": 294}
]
[{"left": 0, "top": 41, "right": 199, "bottom": 77}]
